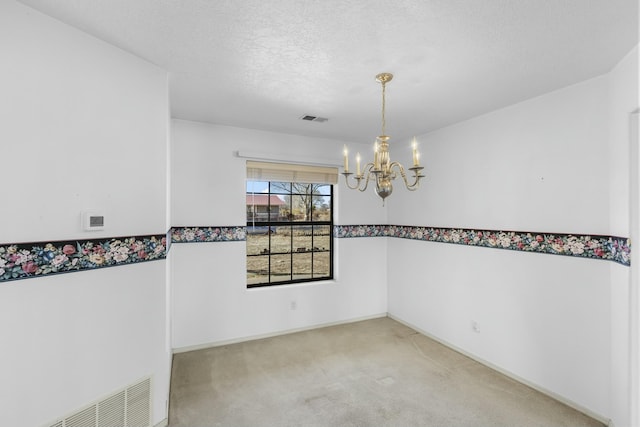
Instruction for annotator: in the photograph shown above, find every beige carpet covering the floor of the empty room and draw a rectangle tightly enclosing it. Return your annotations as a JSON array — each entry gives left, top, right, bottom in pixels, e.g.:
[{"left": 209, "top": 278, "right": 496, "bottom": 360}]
[{"left": 169, "top": 318, "right": 603, "bottom": 427}]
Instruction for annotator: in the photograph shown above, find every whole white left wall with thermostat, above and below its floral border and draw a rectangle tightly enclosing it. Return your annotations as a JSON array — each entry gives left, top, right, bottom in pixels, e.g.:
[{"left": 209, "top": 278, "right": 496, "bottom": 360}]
[{"left": 0, "top": 1, "right": 170, "bottom": 426}]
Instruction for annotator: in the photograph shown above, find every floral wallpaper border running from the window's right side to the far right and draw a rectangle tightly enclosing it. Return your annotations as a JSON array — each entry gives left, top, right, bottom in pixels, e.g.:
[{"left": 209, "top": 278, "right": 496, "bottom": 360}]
[{"left": 333, "top": 225, "right": 631, "bottom": 266}]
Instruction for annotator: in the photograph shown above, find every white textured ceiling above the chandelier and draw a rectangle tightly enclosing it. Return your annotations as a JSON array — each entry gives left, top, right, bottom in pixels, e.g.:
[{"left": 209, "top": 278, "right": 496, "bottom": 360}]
[{"left": 17, "top": 0, "right": 638, "bottom": 142}]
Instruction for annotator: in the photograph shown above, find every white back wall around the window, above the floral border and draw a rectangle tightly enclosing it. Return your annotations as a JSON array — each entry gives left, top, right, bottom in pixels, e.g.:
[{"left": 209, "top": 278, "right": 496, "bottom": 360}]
[{"left": 171, "top": 120, "right": 387, "bottom": 226}]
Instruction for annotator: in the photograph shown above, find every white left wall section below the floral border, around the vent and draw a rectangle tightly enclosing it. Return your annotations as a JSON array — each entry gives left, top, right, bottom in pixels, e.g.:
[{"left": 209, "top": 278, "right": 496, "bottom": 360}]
[{"left": 0, "top": 261, "right": 170, "bottom": 427}]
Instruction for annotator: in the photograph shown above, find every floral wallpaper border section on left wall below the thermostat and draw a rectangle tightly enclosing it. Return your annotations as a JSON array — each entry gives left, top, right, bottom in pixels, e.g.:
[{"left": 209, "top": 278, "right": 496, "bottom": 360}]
[{"left": 0, "top": 234, "right": 167, "bottom": 282}]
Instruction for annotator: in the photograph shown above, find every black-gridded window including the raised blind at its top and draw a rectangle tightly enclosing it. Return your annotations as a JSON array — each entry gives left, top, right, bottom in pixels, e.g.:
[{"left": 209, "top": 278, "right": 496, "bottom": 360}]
[{"left": 246, "top": 162, "right": 337, "bottom": 288}]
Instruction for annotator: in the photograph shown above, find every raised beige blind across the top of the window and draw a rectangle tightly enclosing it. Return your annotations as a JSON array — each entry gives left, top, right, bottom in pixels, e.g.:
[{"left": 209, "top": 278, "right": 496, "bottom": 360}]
[{"left": 247, "top": 160, "right": 338, "bottom": 184}]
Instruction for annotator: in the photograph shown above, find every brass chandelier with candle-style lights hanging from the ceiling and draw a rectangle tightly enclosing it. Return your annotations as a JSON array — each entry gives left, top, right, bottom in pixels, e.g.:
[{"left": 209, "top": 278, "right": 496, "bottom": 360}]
[{"left": 342, "top": 73, "right": 424, "bottom": 206}]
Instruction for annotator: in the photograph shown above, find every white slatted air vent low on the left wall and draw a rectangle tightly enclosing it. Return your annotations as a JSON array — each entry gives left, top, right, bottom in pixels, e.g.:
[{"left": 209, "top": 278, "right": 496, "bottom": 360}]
[{"left": 47, "top": 378, "right": 151, "bottom": 427}]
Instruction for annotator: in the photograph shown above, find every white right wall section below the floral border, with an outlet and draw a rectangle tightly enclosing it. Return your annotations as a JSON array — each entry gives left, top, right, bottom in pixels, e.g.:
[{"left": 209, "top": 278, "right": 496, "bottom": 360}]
[{"left": 388, "top": 239, "right": 611, "bottom": 416}]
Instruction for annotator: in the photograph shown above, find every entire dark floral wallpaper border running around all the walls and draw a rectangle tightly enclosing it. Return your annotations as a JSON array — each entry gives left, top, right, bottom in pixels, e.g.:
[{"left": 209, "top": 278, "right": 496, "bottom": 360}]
[{"left": 0, "top": 225, "right": 631, "bottom": 282}]
